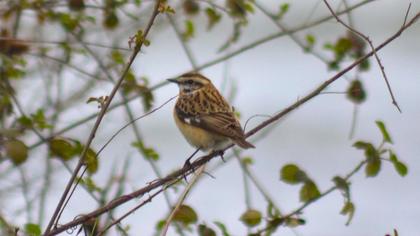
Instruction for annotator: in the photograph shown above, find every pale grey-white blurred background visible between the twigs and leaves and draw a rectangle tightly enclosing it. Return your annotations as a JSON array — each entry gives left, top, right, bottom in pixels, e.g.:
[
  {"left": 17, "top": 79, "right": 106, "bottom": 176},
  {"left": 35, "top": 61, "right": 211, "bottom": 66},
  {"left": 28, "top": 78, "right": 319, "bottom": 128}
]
[{"left": 0, "top": 0, "right": 420, "bottom": 235}]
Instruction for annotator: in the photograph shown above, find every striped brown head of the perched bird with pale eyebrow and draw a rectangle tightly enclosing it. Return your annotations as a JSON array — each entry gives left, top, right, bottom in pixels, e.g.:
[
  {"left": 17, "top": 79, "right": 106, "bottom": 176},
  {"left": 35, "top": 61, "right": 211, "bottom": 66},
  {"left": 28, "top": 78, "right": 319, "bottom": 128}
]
[{"left": 168, "top": 73, "right": 211, "bottom": 95}]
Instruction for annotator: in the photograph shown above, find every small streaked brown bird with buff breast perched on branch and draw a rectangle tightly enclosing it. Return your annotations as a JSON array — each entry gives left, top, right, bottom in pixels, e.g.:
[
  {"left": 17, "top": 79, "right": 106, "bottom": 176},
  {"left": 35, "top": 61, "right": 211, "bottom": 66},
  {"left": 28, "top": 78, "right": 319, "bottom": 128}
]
[{"left": 167, "top": 72, "right": 255, "bottom": 164}]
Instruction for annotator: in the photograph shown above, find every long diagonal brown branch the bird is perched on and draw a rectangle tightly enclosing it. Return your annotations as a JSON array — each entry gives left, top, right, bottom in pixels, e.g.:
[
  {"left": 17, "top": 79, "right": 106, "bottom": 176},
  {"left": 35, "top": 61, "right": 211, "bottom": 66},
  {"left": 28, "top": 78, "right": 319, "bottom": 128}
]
[{"left": 50, "top": 12, "right": 420, "bottom": 235}]
